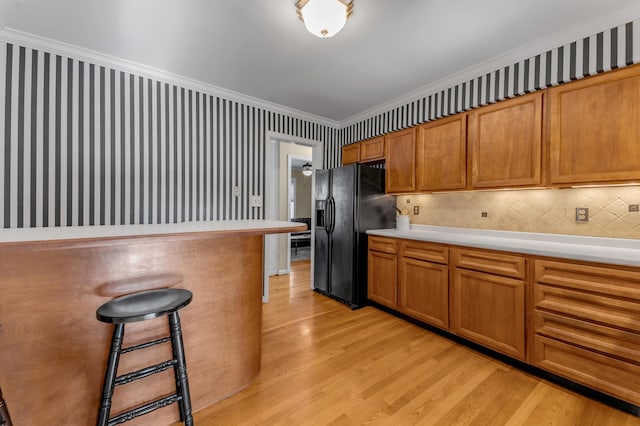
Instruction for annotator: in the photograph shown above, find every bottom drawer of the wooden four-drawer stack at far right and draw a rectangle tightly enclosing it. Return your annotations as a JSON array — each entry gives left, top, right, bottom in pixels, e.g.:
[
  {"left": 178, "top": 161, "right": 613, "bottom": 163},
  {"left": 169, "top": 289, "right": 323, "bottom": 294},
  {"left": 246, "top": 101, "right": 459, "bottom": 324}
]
[{"left": 533, "top": 335, "right": 640, "bottom": 405}]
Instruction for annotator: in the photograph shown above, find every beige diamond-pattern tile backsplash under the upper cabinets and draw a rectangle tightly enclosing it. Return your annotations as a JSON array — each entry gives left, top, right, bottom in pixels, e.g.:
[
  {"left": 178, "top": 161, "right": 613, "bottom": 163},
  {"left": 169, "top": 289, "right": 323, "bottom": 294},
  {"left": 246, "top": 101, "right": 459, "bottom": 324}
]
[{"left": 397, "top": 185, "right": 640, "bottom": 239}]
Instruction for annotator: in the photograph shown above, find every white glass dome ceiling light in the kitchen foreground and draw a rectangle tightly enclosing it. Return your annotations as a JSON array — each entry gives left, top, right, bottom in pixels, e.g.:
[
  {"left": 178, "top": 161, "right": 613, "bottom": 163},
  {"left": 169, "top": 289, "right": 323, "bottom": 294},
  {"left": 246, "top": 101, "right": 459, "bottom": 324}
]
[{"left": 296, "top": 0, "right": 353, "bottom": 38}]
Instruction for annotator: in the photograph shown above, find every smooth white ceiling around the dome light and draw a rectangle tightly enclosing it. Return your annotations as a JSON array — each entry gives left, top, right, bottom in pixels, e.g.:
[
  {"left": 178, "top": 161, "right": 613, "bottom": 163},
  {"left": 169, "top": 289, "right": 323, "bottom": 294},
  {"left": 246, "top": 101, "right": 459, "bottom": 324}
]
[{"left": 0, "top": 0, "right": 640, "bottom": 121}]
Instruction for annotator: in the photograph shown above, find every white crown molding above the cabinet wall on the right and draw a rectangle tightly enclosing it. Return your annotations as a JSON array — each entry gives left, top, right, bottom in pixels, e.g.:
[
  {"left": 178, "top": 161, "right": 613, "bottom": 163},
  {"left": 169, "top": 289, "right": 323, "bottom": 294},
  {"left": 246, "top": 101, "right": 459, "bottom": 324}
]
[{"left": 339, "top": 2, "right": 640, "bottom": 129}]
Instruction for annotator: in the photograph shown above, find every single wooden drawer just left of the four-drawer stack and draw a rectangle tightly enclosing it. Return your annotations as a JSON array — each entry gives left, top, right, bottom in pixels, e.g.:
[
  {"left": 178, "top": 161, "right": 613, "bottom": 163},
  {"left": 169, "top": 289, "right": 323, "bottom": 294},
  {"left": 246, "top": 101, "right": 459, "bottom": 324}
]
[{"left": 453, "top": 249, "right": 525, "bottom": 279}]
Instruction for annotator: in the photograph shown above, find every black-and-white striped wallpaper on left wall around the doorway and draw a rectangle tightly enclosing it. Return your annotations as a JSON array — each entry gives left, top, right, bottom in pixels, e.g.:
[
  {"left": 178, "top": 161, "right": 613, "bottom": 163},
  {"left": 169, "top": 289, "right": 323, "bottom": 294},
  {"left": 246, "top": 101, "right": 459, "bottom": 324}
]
[{"left": 0, "top": 43, "right": 339, "bottom": 228}]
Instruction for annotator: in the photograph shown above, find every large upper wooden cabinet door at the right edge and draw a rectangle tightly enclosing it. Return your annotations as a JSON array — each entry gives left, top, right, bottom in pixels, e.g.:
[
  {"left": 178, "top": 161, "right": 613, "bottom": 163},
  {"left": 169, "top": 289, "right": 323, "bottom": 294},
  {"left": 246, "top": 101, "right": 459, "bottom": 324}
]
[{"left": 548, "top": 66, "right": 640, "bottom": 184}]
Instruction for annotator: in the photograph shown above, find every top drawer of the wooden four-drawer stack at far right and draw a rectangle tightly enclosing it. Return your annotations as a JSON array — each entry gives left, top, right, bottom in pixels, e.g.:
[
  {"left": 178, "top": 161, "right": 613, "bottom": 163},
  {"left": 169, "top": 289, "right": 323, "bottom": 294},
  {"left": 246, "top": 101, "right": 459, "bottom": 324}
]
[{"left": 534, "top": 259, "right": 640, "bottom": 302}]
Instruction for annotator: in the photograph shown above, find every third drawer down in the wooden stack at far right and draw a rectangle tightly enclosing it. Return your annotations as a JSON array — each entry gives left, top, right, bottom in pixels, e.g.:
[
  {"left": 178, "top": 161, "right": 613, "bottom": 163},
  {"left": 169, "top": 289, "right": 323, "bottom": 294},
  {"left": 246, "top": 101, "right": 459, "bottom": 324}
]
[{"left": 533, "top": 310, "right": 640, "bottom": 365}]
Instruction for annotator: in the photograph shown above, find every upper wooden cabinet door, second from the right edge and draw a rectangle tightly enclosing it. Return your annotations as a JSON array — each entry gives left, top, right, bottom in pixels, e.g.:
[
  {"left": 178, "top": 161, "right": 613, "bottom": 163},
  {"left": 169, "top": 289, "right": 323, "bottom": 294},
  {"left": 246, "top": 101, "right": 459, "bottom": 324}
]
[{"left": 468, "top": 92, "right": 543, "bottom": 188}]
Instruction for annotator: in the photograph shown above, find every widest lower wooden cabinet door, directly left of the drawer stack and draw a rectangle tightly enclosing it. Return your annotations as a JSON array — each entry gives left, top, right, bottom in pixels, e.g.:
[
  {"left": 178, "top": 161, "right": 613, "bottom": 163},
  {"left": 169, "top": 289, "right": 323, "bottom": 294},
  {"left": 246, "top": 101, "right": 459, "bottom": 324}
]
[{"left": 451, "top": 268, "right": 525, "bottom": 360}]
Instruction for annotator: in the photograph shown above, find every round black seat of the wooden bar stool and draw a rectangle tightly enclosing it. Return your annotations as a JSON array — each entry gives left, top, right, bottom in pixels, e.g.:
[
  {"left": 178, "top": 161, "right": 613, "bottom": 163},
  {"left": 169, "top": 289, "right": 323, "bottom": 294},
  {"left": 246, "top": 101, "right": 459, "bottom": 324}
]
[{"left": 96, "top": 288, "right": 193, "bottom": 324}]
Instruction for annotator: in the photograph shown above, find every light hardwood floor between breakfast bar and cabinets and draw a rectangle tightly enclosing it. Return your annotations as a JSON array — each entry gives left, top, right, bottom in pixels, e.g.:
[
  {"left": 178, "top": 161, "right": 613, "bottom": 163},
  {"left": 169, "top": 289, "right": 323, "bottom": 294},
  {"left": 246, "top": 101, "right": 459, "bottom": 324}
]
[{"left": 188, "top": 261, "right": 640, "bottom": 426}]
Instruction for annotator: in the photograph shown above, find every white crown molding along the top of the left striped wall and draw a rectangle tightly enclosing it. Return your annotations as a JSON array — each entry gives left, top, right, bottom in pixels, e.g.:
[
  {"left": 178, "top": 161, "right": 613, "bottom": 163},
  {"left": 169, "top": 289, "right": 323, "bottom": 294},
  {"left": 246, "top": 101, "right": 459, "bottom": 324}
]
[{"left": 0, "top": 27, "right": 340, "bottom": 128}]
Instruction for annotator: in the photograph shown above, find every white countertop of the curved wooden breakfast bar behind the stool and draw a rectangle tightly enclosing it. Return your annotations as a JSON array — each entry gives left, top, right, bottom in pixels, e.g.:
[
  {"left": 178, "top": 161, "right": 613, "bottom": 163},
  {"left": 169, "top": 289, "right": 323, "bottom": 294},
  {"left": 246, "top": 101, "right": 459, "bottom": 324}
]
[{"left": 0, "top": 220, "right": 302, "bottom": 243}]
